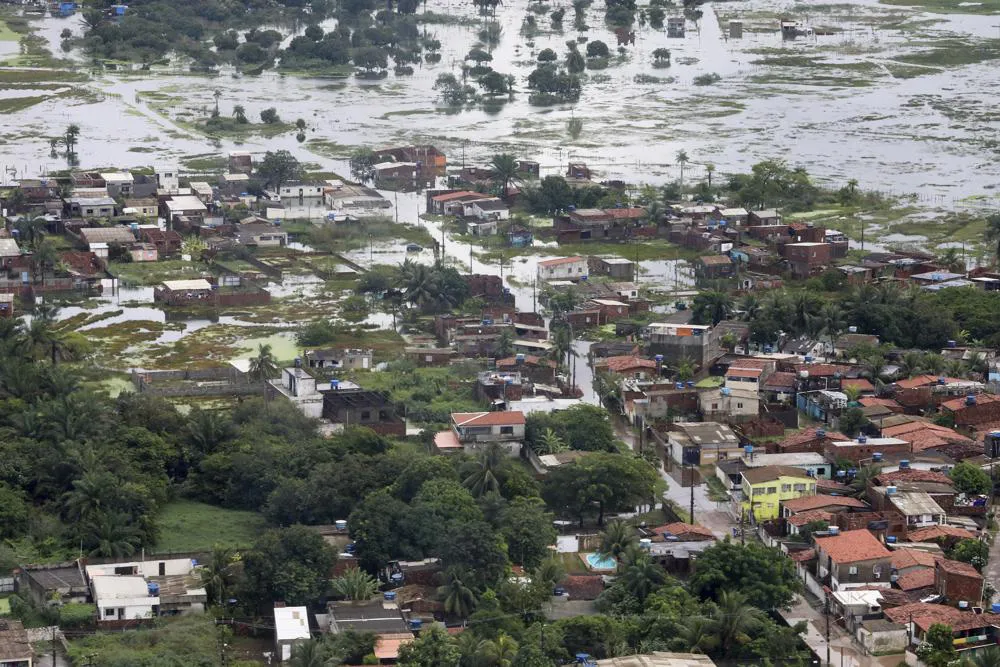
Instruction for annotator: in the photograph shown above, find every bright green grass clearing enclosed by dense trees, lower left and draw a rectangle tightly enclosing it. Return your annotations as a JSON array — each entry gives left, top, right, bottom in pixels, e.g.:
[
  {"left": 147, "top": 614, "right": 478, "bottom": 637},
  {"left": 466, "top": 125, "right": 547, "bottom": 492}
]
[{"left": 156, "top": 500, "right": 265, "bottom": 553}]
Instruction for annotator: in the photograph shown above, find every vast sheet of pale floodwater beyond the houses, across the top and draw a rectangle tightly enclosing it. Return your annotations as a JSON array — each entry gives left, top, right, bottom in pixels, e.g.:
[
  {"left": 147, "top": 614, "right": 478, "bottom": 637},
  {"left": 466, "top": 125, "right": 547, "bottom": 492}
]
[{"left": 0, "top": 0, "right": 1000, "bottom": 205}]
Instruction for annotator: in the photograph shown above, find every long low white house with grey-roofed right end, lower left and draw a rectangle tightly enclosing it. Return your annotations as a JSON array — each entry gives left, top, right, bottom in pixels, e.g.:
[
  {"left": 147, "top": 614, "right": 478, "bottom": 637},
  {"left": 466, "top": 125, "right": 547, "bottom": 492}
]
[{"left": 85, "top": 558, "right": 208, "bottom": 627}]
